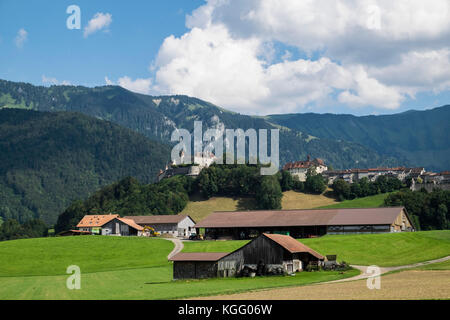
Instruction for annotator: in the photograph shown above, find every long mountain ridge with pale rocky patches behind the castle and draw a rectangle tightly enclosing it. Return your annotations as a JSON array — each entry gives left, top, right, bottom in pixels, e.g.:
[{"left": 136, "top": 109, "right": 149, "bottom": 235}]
[{"left": 0, "top": 80, "right": 404, "bottom": 168}]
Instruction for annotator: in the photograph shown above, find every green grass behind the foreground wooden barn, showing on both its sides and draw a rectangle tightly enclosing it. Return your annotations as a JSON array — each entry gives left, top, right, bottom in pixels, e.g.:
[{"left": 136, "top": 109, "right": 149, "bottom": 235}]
[{"left": 183, "top": 230, "right": 450, "bottom": 267}]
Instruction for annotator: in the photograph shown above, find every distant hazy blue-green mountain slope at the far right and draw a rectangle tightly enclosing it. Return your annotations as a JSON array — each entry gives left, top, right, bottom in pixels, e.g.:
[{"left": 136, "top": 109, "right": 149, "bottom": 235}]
[{"left": 266, "top": 105, "right": 450, "bottom": 171}]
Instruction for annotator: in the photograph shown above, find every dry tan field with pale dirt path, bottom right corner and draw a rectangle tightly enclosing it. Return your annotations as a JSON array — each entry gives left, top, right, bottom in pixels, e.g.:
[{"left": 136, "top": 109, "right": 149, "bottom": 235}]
[{"left": 192, "top": 256, "right": 450, "bottom": 300}]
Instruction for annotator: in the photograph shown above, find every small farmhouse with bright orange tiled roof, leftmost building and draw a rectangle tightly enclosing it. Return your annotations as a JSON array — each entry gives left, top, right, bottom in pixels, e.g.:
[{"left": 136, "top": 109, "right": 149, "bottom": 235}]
[{"left": 77, "top": 214, "right": 144, "bottom": 236}]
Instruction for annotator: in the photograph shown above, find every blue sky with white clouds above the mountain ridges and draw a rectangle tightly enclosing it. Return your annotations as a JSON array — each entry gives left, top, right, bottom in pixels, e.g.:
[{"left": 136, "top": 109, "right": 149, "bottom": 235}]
[{"left": 0, "top": 0, "right": 450, "bottom": 115}]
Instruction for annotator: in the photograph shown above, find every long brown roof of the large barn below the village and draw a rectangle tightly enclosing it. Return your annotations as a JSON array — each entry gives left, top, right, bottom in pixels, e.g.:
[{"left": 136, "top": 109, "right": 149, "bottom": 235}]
[{"left": 195, "top": 207, "right": 403, "bottom": 228}]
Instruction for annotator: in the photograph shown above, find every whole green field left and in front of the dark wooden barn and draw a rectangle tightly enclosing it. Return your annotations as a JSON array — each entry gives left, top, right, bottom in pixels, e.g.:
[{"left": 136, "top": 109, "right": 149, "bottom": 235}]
[{"left": 0, "top": 236, "right": 359, "bottom": 300}]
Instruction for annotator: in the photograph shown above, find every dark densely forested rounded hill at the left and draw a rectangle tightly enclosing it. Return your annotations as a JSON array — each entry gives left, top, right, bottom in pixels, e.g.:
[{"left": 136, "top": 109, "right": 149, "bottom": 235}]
[{"left": 0, "top": 109, "right": 170, "bottom": 224}]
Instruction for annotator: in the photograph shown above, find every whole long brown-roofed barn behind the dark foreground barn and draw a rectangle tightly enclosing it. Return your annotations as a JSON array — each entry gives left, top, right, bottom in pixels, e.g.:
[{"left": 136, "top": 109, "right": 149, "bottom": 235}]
[{"left": 195, "top": 207, "right": 414, "bottom": 239}]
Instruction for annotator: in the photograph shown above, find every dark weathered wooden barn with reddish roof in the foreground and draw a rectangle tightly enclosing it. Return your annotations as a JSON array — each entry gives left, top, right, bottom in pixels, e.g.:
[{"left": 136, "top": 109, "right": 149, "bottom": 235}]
[{"left": 169, "top": 233, "right": 325, "bottom": 279}]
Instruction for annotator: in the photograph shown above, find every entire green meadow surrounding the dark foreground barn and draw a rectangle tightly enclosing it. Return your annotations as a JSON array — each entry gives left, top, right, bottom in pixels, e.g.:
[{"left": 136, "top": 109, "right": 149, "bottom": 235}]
[{"left": 0, "top": 231, "right": 450, "bottom": 300}]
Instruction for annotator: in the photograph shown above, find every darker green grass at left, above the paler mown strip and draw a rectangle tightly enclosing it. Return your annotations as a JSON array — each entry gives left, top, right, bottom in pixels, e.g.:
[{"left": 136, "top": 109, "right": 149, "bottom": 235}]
[{"left": 0, "top": 236, "right": 173, "bottom": 277}]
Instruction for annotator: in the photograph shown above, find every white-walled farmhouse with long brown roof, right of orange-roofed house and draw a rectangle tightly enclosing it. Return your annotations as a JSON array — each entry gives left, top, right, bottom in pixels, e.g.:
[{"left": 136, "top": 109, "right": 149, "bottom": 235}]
[{"left": 125, "top": 214, "right": 195, "bottom": 237}]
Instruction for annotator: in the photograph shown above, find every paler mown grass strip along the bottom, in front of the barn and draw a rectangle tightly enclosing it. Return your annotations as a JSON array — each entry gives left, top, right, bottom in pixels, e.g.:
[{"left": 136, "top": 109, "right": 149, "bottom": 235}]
[{"left": 0, "top": 265, "right": 359, "bottom": 300}]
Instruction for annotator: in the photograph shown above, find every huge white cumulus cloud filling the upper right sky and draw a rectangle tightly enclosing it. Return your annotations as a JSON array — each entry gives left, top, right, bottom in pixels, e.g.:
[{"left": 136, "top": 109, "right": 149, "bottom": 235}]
[{"left": 151, "top": 0, "right": 450, "bottom": 114}]
